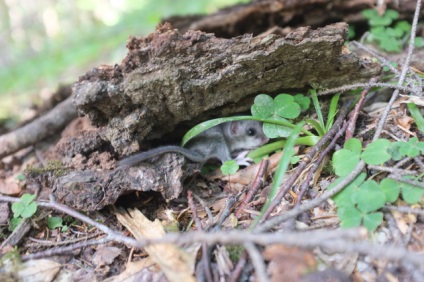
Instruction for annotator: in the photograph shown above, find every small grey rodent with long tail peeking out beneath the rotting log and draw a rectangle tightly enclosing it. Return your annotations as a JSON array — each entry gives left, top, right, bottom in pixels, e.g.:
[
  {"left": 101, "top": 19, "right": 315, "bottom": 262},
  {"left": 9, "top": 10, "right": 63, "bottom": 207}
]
[{"left": 118, "top": 120, "right": 269, "bottom": 167}]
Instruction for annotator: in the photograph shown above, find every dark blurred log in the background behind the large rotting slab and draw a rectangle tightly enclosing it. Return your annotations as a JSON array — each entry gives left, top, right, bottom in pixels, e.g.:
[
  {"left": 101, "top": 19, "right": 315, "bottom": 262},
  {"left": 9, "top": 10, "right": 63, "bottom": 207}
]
[{"left": 164, "top": 0, "right": 424, "bottom": 38}]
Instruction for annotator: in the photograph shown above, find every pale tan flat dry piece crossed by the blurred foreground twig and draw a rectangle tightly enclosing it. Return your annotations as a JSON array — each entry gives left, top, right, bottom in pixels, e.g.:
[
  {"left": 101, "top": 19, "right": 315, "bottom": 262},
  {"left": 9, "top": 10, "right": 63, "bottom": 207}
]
[{"left": 114, "top": 209, "right": 200, "bottom": 282}]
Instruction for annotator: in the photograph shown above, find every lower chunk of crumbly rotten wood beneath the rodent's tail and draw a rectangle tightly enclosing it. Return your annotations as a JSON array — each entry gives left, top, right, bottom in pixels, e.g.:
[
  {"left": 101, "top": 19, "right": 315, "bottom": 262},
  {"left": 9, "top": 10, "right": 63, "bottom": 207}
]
[{"left": 51, "top": 154, "right": 199, "bottom": 211}]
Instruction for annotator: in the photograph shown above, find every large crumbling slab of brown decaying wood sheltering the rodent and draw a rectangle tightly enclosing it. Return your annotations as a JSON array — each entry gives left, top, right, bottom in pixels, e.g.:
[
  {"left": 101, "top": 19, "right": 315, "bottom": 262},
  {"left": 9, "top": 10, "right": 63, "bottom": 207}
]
[{"left": 73, "top": 23, "right": 380, "bottom": 155}]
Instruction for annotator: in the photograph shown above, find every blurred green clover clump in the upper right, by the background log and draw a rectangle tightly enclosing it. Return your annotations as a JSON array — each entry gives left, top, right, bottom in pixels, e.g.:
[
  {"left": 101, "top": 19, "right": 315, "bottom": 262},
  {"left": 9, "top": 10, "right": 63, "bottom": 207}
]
[{"left": 362, "top": 9, "right": 424, "bottom": 52}]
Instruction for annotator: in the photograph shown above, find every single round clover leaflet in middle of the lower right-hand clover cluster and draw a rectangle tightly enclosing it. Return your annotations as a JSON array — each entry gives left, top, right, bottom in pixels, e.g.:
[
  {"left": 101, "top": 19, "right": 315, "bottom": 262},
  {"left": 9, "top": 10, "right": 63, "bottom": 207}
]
[{"left": 352, "top": 180, "right": 386, "bottom": 213}]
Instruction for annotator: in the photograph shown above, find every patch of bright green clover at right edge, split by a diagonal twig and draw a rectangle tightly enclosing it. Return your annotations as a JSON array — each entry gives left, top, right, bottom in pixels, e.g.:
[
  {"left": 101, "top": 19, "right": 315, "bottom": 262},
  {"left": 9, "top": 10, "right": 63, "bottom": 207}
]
[{"left": 329, "top": 138, "right": 424, "bottom": 231}]
